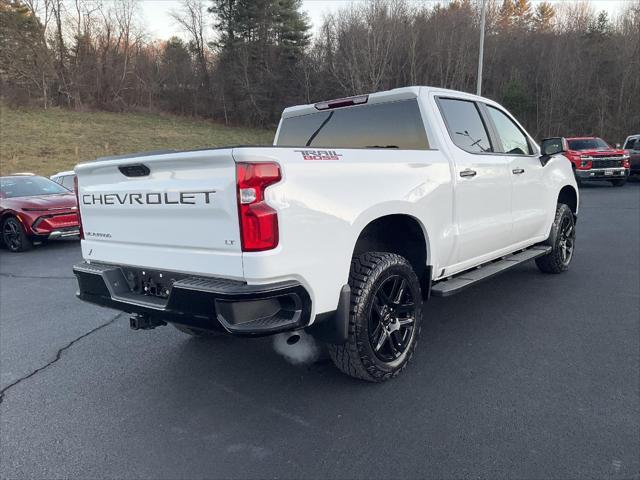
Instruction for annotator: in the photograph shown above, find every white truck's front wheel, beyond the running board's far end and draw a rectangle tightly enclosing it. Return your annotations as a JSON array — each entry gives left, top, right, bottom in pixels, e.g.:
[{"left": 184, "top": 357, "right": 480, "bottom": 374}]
[{"left": 536, "top": 203, "right": 576, "bottom": 273}]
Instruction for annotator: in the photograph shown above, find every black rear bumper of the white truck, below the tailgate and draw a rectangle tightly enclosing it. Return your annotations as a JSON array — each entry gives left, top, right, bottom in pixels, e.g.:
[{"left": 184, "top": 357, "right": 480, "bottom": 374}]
[{"left": 73, "top": 262, "right": 311, "bottom": 336}]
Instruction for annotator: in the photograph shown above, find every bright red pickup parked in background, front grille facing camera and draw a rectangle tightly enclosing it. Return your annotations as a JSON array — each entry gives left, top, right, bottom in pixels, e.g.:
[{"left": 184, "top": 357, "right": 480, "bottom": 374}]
[{"left": 564, "top": 137, "right": 630, "bottom": 187}]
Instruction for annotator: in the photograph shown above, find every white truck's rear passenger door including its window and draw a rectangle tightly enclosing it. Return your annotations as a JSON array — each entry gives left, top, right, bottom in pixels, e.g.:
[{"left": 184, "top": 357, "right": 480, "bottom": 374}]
[{"left": 437, "top": 97, "right": 511, "bottom": 266}]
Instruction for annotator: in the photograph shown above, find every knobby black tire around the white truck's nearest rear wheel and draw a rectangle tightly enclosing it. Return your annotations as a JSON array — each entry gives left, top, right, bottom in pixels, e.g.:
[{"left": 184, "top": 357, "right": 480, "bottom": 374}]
[{"left": 328, "top": 252, "right": 422, "bottom": 382}]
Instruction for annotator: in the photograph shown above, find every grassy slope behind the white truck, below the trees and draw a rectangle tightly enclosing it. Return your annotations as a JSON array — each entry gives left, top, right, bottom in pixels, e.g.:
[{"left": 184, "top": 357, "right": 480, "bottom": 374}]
[{"left": 0, "top": 103, "right": 274, "bottom": 176}]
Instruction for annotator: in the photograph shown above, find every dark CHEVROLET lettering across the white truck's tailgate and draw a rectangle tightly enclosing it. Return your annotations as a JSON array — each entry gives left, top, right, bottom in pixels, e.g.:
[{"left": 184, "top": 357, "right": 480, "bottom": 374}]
[{"left": 82, "top": 190, "right": 216, "bottom": 205}]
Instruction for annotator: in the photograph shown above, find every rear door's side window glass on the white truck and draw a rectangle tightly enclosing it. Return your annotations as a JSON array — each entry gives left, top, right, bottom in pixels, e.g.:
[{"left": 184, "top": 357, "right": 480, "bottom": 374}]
[{"left": 438, "top": 98, "right": 493, "bottom": 153}]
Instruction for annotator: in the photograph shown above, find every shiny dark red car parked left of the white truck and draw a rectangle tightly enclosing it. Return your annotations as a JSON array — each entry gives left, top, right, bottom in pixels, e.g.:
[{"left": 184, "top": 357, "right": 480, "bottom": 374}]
[{"left": 0, "top": 175, "right": 80, "bottom": 252}]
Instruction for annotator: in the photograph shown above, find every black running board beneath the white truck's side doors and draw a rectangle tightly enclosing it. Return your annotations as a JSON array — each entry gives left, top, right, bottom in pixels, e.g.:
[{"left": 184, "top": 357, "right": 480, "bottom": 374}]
[{"left": 431, "top": 245, "right": 551, "bottom": 297}]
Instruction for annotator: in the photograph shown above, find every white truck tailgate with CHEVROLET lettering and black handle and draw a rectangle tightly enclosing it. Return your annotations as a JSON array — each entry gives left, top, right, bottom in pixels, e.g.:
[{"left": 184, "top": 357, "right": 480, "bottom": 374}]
[{"left": 75, "top": 149, "right": 243, "bottom": 279}]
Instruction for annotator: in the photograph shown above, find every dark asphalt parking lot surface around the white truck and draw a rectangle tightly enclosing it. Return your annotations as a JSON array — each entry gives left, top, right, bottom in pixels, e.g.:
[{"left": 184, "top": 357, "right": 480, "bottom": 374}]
[{"left": 0, "top": 182, "right": 640, "bottom": 479}]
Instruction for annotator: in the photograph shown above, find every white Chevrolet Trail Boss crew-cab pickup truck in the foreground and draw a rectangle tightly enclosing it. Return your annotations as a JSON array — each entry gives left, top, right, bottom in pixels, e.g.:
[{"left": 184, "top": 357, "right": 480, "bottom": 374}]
[{"left": 74, "top": 87, "right": 578, "bottom": 382}]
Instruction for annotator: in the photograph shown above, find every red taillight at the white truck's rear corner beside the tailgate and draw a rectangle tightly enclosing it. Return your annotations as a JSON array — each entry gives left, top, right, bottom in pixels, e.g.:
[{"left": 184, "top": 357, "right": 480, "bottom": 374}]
[{"left": 236, "top": 162, "right": 282, "bottom": 252}]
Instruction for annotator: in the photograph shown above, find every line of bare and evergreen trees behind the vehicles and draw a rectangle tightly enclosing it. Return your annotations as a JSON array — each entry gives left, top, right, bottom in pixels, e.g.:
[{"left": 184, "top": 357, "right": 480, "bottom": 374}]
[{"left": 0, "top": 0, "right": 640, "bottom": 142}]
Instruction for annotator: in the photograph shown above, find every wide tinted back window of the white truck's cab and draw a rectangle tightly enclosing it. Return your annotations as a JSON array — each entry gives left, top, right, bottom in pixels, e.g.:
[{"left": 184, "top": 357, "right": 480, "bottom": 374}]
[{"left": 277, "top": 100, "right": 429, "bottom": 150}]
